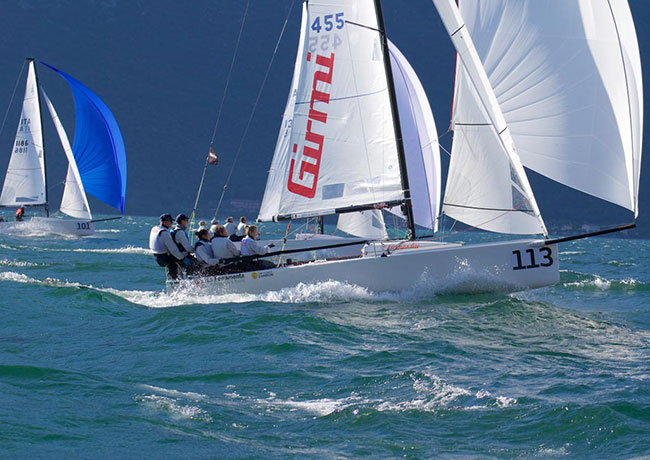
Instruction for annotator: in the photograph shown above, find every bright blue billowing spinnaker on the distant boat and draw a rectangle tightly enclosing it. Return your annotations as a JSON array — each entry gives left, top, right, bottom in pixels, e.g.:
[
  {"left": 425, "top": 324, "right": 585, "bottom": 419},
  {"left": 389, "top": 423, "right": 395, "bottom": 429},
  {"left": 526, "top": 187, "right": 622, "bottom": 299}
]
[{"left": 43, "top": 62, "right": 126, "bottom": 214}]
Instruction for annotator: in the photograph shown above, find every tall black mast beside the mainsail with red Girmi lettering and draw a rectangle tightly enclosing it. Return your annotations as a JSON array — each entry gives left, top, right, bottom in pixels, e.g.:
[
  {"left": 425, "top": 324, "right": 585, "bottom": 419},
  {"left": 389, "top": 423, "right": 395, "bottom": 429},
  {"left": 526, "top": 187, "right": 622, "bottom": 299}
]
[{"left": 375, "top": 0, "right": 416, "bottom": 240}]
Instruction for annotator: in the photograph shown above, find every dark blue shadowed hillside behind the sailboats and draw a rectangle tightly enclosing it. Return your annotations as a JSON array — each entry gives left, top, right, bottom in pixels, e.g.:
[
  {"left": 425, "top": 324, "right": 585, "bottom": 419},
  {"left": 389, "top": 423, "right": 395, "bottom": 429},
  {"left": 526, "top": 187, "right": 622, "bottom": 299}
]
[{"left": 0, "top": 0, "right": 650, "bottom": 236}]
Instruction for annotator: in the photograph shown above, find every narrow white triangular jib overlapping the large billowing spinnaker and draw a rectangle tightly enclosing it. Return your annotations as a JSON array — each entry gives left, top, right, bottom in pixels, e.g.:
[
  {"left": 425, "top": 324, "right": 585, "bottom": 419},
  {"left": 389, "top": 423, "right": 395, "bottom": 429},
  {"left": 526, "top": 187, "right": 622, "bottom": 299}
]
[{"left": 433, "top": 0, "right": 547, "bottom": 235}]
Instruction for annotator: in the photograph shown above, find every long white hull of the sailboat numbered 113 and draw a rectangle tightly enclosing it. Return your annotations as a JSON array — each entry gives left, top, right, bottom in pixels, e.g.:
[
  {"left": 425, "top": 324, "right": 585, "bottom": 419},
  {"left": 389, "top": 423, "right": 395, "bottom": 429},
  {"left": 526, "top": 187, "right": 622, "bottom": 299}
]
[{"left": 167, "top": 239, "right": 560, "bottom": 294}]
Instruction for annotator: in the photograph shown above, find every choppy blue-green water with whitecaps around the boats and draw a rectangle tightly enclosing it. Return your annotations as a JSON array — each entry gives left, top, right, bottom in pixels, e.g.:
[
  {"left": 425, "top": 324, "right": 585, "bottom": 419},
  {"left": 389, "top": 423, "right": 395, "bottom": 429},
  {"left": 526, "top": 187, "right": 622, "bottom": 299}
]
[{"left": 0, "top": 217, "right": 650, "bottom": 460}]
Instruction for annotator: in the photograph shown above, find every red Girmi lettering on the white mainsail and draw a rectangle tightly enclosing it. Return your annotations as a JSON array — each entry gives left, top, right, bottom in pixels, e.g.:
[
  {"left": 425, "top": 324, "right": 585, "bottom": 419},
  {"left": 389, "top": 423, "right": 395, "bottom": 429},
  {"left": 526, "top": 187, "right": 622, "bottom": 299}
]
[{"left": 287, "top": 53, "right": 334, "bottom": 199}]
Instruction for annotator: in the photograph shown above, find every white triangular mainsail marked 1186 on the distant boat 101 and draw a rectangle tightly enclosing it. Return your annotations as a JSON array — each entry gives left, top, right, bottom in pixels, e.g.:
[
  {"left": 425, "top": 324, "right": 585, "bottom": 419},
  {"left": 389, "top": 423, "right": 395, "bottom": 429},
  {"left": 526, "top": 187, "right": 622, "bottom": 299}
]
[{"left": 0, "top": 61, "right": 47, "bottom": 206}]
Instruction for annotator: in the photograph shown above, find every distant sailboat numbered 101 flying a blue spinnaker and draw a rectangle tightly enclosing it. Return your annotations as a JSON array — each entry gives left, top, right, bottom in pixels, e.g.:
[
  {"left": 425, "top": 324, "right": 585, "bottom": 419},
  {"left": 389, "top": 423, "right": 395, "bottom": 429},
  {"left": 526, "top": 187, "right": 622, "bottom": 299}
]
[{"left": 0, "top": 58, "right": 126, "bottom": 236}]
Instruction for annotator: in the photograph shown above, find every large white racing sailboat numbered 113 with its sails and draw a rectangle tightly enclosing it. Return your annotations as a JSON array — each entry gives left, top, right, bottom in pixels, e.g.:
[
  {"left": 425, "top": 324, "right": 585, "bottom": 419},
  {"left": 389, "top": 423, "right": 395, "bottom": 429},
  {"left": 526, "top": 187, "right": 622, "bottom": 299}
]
[{"left": 168, "top": 0, "right": 643, "bottom": 293}]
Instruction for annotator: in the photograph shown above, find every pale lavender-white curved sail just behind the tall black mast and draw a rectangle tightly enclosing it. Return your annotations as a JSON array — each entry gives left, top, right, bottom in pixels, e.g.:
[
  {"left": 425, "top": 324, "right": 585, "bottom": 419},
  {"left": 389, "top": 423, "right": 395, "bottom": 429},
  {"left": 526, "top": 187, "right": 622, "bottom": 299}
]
[{"left": 388, "top": 42, "right": 442, "bottom": 232}]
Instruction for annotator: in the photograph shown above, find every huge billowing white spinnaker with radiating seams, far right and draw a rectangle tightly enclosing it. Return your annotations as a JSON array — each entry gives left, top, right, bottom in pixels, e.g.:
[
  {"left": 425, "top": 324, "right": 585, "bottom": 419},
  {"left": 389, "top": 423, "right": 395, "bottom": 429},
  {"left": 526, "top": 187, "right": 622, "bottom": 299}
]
[{"left": 457, "top": 0, "right": 643, "bottom": 215}]
